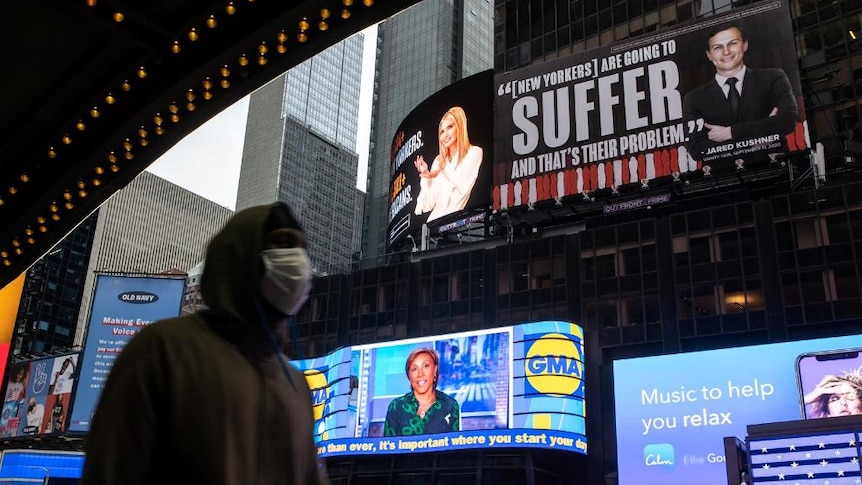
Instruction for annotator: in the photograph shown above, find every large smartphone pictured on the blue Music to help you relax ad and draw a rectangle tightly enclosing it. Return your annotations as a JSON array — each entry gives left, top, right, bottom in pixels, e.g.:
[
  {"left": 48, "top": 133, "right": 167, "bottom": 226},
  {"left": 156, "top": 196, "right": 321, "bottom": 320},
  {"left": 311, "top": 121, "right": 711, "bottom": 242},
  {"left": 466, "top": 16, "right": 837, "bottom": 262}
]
[{"left": 796, "top": 349, "right": 862, "bottom": 419}]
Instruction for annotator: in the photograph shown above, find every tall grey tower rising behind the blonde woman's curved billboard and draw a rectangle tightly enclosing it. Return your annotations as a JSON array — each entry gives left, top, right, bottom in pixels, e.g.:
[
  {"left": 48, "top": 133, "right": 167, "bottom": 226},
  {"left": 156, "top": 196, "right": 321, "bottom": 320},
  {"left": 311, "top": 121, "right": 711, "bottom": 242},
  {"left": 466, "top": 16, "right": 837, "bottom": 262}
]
[{"left": 362, "top": 0, "right": 494, "bottom": 259}]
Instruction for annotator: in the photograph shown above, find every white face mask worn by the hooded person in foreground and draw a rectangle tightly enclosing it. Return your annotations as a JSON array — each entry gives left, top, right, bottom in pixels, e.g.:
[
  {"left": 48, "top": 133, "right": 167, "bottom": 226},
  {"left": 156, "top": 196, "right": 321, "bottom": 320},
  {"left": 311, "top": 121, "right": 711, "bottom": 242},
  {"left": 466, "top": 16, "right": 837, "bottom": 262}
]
[{"left": 260, "top": 248, "right": 311, "bottom": 315}]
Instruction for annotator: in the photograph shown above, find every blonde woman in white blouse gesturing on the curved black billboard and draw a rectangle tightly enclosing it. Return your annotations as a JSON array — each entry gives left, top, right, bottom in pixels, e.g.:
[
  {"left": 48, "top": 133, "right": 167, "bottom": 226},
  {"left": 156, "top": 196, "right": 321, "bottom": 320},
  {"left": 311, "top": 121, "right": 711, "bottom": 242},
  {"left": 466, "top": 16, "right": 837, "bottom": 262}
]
[{"left": 413, "top": 106, "right": 483, "bottom": 222}]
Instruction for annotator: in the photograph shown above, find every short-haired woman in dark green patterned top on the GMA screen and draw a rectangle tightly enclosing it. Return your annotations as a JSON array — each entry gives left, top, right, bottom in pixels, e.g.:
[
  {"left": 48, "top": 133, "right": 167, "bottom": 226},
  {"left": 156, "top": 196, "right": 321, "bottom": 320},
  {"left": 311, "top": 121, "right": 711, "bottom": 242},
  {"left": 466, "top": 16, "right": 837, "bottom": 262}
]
[{"left": 383, "top": 347, "right": 461, "bottom": 436}]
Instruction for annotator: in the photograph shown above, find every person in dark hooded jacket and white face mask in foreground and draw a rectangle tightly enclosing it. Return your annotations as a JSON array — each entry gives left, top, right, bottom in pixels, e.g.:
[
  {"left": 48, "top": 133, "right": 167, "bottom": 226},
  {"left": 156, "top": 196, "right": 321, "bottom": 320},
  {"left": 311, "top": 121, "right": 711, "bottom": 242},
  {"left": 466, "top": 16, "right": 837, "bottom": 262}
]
[{"left": 81, "top": 202, "right": 328, "bottom": 485}]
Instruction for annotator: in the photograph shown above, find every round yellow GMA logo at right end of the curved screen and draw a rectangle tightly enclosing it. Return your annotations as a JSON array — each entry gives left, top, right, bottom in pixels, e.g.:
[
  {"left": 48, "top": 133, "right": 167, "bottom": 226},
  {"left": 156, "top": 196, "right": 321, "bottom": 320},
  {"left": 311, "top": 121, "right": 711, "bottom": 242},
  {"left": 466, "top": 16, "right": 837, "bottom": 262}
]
[{"left": 524, "top": 333, "right": 584, "bottom": 396}]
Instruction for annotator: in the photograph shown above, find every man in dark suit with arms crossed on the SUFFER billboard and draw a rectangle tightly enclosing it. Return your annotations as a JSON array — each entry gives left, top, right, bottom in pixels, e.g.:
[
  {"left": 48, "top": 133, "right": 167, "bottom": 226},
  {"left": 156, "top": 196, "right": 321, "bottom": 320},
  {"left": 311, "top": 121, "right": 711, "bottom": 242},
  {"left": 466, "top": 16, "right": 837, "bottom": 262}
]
[{"left": 683, "top": 24, "right": 798, "bottom": 164}]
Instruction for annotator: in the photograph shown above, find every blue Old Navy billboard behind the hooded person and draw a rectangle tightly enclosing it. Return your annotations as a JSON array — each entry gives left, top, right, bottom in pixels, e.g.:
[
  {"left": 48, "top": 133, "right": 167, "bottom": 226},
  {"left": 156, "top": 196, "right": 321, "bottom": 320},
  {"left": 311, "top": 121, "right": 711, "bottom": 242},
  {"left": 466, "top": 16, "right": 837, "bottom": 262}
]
[{"left": 69, "top": 274, "right": 186, "bottom": 432}]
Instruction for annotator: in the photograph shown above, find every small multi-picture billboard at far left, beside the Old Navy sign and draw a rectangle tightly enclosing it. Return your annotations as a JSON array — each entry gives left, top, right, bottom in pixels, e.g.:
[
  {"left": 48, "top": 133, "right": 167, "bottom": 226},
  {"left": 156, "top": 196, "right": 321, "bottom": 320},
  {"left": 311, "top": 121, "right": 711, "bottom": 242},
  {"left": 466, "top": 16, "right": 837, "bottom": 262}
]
[{"left": 0, "top": 353, "right": 78, "bottom": 438}]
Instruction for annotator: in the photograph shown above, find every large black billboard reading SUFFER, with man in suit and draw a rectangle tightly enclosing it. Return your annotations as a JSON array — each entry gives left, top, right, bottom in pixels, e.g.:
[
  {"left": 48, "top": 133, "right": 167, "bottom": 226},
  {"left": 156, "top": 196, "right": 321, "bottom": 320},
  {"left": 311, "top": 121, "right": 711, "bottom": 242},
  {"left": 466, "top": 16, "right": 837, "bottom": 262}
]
[{"left": 493, "top": 1, "right": 810, "bottom": 209}]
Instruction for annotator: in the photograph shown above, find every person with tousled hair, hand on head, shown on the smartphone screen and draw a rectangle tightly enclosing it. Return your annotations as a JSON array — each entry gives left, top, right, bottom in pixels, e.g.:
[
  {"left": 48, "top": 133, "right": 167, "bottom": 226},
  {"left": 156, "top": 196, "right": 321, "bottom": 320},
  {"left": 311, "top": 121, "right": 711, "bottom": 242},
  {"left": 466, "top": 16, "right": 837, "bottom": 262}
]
[{"left": 805, "top": 368, "right": 862, "bottom": 418}]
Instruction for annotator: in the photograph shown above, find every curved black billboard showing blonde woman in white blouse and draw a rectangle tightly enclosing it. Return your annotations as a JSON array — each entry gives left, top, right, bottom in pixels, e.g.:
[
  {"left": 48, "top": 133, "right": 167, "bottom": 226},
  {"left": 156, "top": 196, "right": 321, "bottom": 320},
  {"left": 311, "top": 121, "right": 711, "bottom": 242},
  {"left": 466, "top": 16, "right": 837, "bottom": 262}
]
[{"left": 386, "top": 70, "right": 493, "bottom": 251}]
